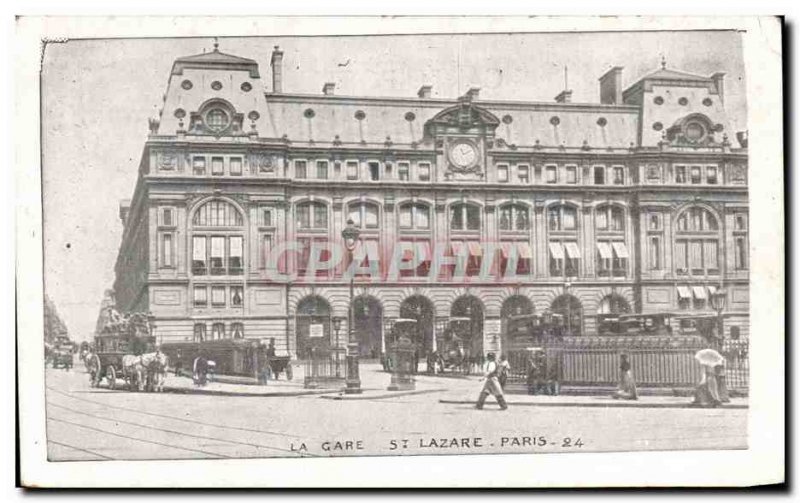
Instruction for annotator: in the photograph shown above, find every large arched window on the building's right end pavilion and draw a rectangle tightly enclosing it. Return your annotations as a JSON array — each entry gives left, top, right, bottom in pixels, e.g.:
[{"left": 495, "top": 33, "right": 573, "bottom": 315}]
[{"left": 675, "top": 206, "right": 720, "bottom": 276}]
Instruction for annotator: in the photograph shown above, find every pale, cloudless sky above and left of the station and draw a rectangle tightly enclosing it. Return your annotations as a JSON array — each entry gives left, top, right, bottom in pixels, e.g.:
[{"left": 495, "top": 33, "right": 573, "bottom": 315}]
[{"left": 42, "top": 31, "right": 747, "bottom": 340}]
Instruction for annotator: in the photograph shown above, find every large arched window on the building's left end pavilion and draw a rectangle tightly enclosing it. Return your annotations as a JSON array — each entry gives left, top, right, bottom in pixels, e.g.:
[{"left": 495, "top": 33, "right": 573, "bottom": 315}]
[{"left": 192, "top": 199, "right": 244, "bottom": 276}]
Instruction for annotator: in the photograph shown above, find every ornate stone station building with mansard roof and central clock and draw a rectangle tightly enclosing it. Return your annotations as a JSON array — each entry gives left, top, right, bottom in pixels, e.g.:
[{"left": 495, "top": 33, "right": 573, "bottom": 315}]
[{"left": 114, "top": 47, "right": 749, "bottom": 357}]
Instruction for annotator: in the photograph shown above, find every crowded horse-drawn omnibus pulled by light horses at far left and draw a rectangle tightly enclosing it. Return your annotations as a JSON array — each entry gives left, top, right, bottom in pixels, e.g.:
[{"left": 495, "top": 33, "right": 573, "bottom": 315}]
[{"left": 84, "top": 313, "right": 167, "bottom": 391}]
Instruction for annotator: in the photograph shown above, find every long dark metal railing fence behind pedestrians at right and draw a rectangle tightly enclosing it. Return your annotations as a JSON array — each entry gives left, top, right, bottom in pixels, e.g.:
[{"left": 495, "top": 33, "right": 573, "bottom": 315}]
[{"left": 508, "top": 337, "right": 749, "bottom": 391}]
